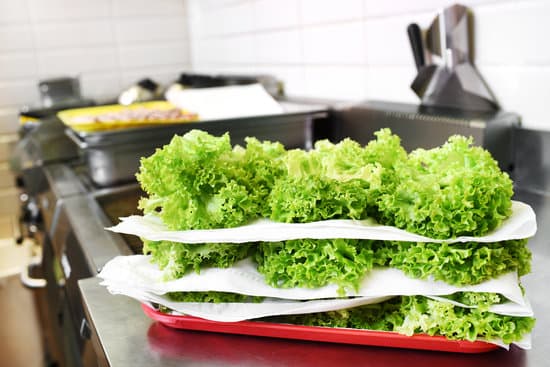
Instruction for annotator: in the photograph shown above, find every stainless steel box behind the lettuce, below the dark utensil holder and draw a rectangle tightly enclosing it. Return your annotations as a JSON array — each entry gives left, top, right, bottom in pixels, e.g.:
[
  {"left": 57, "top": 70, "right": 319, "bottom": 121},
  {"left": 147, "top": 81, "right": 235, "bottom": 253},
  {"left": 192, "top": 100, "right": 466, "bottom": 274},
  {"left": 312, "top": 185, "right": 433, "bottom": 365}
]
[{"left": 333, "top": 101, "right": 520, "bottom": 173}]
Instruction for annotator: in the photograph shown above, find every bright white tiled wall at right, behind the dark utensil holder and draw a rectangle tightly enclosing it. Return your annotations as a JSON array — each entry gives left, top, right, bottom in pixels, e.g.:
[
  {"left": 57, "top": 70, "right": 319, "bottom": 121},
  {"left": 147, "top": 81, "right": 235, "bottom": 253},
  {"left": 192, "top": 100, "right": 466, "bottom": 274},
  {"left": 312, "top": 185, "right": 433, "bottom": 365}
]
[{"left": 188, "top": 0, "right": 550, "bottom": 130}]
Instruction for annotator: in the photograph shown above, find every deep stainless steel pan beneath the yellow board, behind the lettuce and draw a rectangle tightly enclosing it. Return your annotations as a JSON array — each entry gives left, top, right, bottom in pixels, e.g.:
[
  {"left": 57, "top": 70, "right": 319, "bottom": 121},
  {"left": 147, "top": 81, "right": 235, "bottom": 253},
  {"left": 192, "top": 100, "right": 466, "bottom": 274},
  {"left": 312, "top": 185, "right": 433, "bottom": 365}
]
[{"left": 67, "top": 103, "right": 326, "bottom": 187}]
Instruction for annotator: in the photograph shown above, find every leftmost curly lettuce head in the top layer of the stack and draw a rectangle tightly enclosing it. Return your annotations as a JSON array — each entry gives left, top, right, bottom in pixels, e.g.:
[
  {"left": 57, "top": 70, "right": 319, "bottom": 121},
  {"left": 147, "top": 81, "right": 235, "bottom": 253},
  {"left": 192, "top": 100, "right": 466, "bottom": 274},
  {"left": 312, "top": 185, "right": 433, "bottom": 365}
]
[{"left": 136, "top": 130, "right": 259, "bottom": 230}]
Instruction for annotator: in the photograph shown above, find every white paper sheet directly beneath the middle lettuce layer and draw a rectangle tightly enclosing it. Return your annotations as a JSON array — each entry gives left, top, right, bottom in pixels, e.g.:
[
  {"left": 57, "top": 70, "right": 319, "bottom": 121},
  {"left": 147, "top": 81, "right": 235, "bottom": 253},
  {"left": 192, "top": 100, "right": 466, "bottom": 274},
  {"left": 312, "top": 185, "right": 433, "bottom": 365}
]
[{"left": 99, "top": 255, "right": 533, "bottom": 321}]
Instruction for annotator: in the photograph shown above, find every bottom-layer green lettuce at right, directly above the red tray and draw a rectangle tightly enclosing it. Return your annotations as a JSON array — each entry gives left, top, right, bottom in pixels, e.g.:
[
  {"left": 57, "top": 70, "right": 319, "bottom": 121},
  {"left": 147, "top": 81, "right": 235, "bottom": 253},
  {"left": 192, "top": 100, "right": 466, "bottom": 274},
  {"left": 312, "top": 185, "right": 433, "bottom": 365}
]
[{"left": 280, "top": 296, "right": 535, "bottom": 343}]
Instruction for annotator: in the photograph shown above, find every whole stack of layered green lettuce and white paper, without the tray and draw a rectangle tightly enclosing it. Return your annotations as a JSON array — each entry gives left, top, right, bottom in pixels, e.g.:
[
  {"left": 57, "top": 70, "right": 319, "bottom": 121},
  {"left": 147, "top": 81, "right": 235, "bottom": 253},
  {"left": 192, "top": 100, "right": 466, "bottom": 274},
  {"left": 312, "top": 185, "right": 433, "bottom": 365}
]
[{"left": 100, "top": 129, "right": 536, "bottom": 347}]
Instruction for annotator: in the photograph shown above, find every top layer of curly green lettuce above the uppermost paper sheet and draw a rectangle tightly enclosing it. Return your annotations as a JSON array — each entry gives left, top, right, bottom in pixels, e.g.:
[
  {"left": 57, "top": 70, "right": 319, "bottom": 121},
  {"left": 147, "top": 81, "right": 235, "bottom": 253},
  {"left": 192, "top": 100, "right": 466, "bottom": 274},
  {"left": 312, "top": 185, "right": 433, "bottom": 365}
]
[{"left": 137, "top": 129, "right": 513, "bottom": 239}]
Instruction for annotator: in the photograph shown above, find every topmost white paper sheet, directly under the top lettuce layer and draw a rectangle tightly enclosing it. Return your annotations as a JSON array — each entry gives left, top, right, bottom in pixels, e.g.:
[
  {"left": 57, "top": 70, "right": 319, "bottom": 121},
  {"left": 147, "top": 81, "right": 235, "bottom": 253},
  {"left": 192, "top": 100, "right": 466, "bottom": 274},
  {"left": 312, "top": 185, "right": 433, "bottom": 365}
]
[{"left": 107, "top": 201, "right": 537, "bottom": 243}]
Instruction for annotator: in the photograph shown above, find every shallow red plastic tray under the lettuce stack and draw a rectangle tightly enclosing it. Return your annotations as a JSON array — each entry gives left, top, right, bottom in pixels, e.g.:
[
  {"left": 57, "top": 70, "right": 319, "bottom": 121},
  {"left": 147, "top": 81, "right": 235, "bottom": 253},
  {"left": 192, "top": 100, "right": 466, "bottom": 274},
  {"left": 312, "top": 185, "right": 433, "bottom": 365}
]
[{"left": 142, "top": 304, "right": 498, "bottom": 353}]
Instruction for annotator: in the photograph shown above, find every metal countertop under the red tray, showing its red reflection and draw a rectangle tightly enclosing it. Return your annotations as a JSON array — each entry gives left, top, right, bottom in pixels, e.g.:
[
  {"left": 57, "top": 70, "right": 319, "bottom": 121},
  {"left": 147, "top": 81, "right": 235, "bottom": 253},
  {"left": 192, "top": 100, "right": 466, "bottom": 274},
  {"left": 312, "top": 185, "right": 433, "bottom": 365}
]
[{"left": 79, "top": 192, "right": 550, "bottom": 367}]
